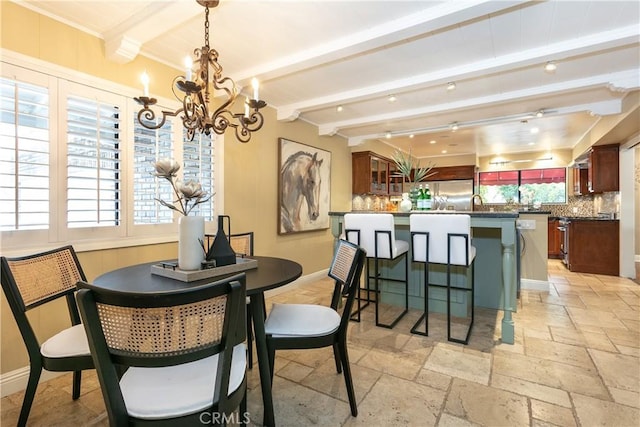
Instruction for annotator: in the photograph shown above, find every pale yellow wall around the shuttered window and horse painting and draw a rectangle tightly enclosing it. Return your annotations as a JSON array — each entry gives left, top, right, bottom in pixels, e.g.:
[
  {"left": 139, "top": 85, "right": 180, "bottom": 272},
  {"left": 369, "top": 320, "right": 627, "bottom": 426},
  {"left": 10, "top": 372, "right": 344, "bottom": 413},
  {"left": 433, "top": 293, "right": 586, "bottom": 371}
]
[{"left": 0, "top": 1, "right": 351, "bottom": 373}]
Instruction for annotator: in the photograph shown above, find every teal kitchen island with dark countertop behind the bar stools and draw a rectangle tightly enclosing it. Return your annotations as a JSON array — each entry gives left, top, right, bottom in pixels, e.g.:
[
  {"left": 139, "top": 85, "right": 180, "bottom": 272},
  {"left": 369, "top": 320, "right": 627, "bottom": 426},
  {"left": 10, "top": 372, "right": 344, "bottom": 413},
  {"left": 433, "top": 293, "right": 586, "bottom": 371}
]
[{"left": 329, "top": 211, "right": 519, "bottom": 344}]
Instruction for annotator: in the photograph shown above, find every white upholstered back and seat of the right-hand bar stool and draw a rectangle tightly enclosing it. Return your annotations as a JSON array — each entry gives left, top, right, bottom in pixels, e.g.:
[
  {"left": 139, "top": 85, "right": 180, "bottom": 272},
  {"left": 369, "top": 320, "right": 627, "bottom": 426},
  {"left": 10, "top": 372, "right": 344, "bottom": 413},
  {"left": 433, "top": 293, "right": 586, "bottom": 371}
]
[{"left": 409, "top": 214, "right": 476, "bottom": 266}]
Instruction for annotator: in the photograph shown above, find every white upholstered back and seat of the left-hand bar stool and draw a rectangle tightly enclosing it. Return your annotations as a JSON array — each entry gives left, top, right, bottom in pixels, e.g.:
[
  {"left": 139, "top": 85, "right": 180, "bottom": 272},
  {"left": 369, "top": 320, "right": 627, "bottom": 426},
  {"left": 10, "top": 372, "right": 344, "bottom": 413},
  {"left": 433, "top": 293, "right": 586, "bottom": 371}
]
[{"left": 344, "top": 213, "right": 409, "bottom": 259}]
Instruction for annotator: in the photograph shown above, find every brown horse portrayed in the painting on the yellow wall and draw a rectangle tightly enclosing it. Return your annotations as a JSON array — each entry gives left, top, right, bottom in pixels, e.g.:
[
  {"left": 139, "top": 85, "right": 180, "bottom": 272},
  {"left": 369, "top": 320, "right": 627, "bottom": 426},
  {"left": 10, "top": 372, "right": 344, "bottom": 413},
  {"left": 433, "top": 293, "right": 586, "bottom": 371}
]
[{"left": 280, "top": 146, "right": 328, "bottom": 233}]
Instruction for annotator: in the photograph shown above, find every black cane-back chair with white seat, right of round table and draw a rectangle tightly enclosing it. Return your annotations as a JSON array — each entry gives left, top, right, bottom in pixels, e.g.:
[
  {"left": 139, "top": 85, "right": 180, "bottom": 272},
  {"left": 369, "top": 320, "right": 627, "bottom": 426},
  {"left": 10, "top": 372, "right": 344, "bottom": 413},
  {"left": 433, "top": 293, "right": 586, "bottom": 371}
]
[{"left": 265, "top": 240, "right": 366, "bottom": 417}]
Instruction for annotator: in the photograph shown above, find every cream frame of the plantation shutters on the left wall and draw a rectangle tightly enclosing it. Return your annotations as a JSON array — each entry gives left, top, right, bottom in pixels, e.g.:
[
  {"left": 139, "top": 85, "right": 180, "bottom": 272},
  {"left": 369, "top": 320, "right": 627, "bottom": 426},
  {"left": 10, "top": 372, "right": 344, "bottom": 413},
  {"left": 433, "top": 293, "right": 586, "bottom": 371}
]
[{"left": 0, "top": 49, "right": 224, "bottom": 256}]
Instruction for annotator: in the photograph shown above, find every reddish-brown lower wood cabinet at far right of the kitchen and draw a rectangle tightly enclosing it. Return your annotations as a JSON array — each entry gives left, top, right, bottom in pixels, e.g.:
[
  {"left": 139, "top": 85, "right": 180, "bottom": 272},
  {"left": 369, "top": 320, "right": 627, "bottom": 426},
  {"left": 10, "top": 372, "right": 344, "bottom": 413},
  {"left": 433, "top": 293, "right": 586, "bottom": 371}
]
[{"left": 567, "top": 219, "right": 620, "bottom": 276}]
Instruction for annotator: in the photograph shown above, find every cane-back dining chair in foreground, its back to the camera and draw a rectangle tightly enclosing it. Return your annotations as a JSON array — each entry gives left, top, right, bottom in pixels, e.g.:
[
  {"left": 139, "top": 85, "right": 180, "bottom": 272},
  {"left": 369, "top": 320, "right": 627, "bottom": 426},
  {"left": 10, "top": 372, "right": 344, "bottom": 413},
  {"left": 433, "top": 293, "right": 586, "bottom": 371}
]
[{"left": 77, "top": 273, "right": 247, "bottom": 426}]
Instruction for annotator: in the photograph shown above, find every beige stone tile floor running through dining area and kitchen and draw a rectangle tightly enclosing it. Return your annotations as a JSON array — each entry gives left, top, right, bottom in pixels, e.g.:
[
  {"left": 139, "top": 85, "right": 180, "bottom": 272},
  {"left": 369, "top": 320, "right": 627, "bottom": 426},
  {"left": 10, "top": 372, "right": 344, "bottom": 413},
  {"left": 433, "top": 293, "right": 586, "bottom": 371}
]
[{"left": 0, "top": 260, "right": 640, "bottom": 426}]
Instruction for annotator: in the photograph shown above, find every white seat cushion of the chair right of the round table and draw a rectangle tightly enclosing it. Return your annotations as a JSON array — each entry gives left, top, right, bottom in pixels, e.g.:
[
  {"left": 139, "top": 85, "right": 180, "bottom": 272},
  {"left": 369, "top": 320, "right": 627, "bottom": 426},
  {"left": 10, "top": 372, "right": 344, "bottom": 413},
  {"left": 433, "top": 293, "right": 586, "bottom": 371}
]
[{"left": 264, "top": 304, "right": 340, "bottom": 337}]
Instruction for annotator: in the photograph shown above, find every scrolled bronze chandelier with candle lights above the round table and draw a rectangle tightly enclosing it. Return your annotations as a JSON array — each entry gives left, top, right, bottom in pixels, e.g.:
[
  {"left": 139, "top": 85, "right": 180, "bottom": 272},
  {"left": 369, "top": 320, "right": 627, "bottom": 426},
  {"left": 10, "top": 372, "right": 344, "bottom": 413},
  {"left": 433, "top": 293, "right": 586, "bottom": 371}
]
[{"left": 134, "top": 0, "right": 267, "bottom": 142}]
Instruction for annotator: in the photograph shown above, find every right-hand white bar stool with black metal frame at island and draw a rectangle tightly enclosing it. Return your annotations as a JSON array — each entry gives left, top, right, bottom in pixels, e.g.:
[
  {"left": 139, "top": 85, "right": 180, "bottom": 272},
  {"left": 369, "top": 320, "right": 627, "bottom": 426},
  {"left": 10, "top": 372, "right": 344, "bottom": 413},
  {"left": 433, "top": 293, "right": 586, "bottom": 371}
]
[{"left": 409, "top": 214, "right": 476, "bottom": 344}]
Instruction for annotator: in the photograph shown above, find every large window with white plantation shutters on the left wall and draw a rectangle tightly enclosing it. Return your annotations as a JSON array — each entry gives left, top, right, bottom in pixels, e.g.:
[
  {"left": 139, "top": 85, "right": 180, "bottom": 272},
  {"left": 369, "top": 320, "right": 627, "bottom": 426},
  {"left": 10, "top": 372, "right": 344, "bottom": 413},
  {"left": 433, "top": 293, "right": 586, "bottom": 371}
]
[{"left": 0, "top": 58, "right": 222, "bottom": 250}]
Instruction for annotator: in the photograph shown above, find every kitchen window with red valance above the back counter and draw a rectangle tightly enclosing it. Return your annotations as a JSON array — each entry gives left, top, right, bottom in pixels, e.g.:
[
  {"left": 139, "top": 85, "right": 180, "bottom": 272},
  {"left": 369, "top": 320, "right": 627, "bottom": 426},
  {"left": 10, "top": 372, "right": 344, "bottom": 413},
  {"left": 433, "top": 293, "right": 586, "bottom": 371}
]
[{"left": 479, "top": 168, "right": 567, "bottom": 204}]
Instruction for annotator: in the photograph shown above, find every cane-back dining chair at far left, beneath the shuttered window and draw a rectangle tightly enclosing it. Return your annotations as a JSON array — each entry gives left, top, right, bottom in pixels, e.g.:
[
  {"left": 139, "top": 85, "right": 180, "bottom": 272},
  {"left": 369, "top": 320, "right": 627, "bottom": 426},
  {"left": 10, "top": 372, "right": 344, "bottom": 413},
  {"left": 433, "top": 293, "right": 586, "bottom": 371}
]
[{"left": 0, "top": 246, "right": 93, "bottom": 426}]
